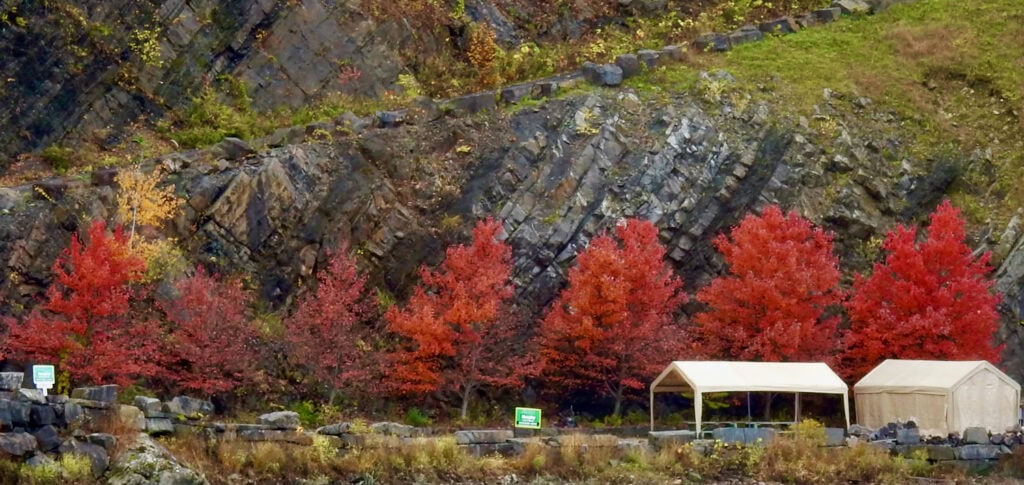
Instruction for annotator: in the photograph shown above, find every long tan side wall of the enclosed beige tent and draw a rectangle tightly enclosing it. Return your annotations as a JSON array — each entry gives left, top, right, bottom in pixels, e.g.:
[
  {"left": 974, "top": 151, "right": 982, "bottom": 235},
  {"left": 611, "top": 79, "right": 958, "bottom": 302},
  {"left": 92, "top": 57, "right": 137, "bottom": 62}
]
[{"left": 854, "top": 392, "right": 948, "bottom": 435}]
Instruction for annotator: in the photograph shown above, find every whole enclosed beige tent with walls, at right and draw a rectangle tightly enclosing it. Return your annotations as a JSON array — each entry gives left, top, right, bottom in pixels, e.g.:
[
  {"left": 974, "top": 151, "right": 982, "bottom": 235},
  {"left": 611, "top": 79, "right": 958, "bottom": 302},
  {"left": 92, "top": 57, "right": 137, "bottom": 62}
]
[{"left": 853, "top": 360, "right": 1021, "bottom": 435}]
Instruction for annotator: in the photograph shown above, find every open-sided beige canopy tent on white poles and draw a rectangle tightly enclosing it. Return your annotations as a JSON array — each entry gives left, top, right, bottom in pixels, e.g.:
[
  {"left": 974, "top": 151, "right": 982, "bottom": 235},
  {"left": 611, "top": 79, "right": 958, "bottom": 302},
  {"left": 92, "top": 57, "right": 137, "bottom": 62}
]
[{"left": 650, "top": 360, "right": 850, "bottom": 433}]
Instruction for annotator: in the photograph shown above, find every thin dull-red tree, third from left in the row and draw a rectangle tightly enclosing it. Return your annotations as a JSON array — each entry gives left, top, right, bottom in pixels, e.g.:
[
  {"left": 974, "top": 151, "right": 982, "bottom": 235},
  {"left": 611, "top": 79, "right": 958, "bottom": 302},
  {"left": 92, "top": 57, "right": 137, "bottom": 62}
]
[{"left": 285, "top": 251, "right": 377, "bottom": 400}]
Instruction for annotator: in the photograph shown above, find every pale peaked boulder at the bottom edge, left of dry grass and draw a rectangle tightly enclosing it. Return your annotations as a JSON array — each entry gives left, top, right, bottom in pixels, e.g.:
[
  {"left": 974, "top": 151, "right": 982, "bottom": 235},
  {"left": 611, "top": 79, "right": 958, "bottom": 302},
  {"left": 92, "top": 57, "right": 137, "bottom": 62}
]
[{"left": 106, "top": 435, "right": 207, "bottom": 485}]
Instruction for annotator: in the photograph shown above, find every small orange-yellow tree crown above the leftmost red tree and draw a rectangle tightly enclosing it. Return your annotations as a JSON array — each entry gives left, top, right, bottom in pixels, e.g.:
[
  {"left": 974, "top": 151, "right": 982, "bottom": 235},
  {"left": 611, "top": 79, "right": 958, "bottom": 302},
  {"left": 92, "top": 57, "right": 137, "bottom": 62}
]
[{"left": 115, "top": 168, "right": 184, "bottom": 239}]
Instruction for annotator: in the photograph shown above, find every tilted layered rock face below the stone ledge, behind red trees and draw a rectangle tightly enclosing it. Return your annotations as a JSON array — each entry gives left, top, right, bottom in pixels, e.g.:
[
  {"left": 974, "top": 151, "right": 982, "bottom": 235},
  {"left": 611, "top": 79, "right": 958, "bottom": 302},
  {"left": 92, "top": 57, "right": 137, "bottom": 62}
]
[{"left": 0, "top": 73, "right": 1024, "bottom": 378}]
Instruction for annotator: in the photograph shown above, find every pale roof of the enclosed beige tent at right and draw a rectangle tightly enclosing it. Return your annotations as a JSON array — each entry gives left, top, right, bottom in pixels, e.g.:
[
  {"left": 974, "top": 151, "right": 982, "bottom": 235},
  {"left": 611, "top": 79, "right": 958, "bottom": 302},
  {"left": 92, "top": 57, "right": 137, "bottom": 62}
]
[{"left": 853, "top": 359, "right": 1021, "bottom": 394}]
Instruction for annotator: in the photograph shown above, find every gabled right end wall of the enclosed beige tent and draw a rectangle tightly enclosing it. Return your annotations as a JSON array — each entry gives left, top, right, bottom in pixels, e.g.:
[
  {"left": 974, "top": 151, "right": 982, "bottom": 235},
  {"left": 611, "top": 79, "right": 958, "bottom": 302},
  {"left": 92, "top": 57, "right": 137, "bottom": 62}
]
[{"left": 949, "top": 368, "right": 1018, "bottom": 433}]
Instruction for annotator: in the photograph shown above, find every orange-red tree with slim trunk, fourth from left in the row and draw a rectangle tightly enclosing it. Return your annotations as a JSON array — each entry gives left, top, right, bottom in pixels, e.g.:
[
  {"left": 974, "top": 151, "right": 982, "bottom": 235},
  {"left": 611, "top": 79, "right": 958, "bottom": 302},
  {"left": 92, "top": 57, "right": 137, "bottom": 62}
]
[{"left": 385, "top": 219, "right": 530, "bottom": 417}]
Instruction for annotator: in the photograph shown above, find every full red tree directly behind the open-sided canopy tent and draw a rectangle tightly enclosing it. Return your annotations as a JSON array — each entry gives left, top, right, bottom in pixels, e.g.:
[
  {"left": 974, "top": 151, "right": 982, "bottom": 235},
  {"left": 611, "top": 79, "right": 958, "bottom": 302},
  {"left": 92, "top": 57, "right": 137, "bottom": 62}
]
[{"left": 693, "top": 206, "right": 843, "bottom": 362}]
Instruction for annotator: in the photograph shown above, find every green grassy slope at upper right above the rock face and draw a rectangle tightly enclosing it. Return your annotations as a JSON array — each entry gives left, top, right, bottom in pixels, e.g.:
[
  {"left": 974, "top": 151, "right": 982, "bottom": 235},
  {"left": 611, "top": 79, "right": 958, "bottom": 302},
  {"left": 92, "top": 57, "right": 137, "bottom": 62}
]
[{"left": 634, "top": 0, "right": 1024, "bottom": 222}]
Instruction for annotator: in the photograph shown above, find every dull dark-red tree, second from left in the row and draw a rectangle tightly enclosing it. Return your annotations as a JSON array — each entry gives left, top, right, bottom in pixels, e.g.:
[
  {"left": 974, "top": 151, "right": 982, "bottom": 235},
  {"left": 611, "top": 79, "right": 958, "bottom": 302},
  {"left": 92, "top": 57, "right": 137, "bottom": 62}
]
[{"left": 158, "top": 268, "right": 257, "bottom": 396}]
